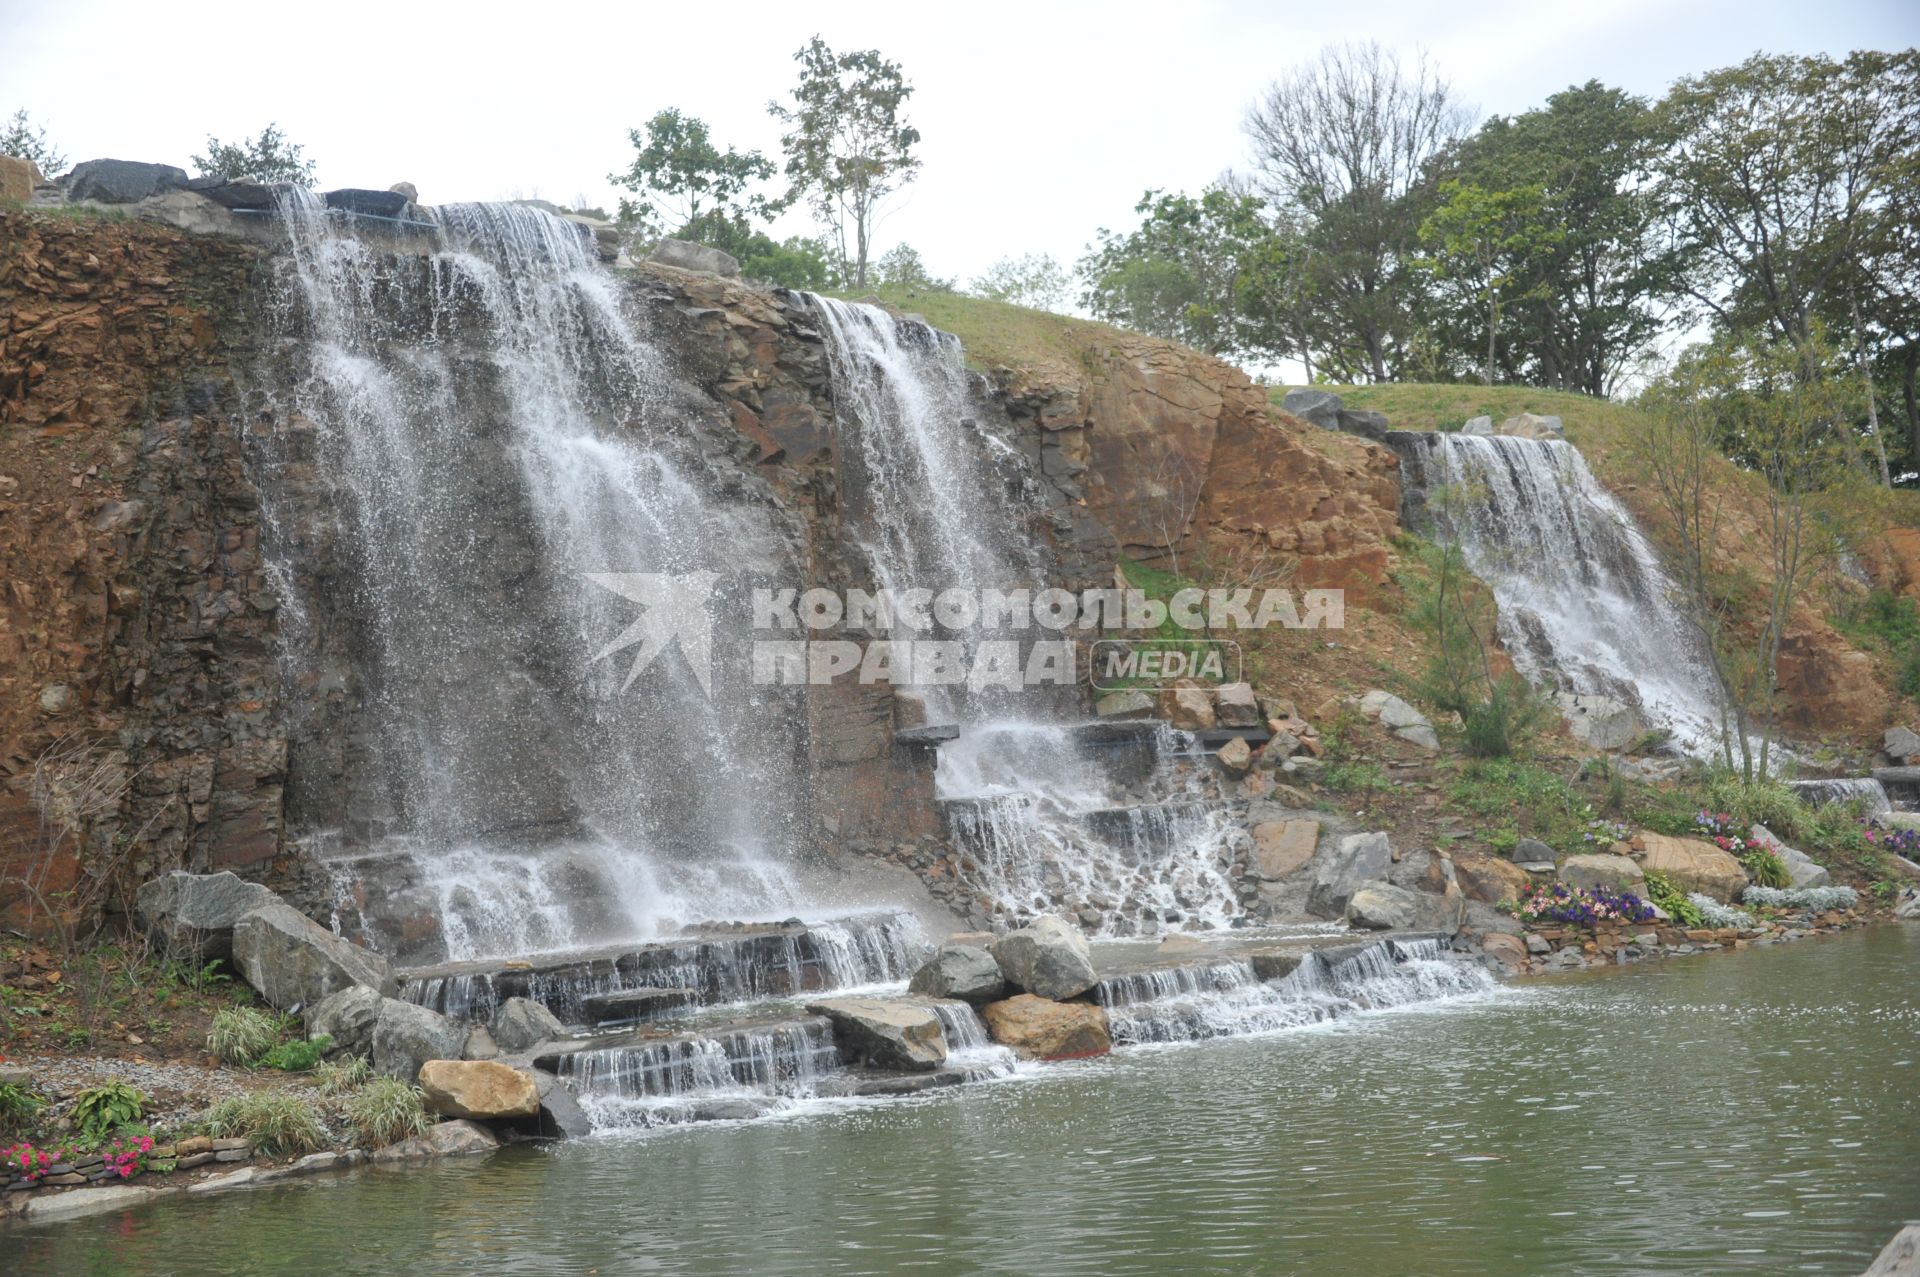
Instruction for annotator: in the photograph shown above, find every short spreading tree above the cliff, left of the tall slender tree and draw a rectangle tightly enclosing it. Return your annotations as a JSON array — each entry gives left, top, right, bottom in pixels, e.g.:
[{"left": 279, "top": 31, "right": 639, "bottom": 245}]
[{"left": 607, "top": 108, "right": 785, "bottom": 242}]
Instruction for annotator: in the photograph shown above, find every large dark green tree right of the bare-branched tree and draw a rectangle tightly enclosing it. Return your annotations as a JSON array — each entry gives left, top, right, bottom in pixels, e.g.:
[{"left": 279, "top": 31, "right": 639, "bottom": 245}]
[{"left": 1444, "top": 81, "right": 1680, "bottom": 396}]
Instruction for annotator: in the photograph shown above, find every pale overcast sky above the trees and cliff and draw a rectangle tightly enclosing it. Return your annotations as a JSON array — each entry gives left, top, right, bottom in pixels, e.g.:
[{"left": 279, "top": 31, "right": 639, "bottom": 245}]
[{"left": 11, "top": 0, "right": 1920, "bottom": 278}]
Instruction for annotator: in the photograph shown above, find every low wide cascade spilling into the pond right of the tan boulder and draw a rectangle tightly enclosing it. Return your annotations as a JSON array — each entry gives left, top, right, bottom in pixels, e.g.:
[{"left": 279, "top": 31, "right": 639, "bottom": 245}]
[{"left": 1094, "top": 939, "right": 1496, "bottom": 1045}]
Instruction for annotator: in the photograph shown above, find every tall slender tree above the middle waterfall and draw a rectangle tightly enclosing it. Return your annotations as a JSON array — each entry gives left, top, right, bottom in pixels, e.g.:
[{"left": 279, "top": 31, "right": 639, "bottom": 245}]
[{"left": 766, "top": 36, "right": 920, "bottom": 288}]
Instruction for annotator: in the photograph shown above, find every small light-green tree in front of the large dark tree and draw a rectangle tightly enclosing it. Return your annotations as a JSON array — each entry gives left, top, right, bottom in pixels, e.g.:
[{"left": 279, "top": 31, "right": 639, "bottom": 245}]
[{"left": 1421, "top": 181, "right": 1561, "bottom": 386}]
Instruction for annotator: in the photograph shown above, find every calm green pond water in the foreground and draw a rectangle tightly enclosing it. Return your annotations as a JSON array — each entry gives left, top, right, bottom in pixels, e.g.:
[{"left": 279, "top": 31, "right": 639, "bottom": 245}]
[{"left": 0, "top": 926, "right": 1920, "bottom": 1277}]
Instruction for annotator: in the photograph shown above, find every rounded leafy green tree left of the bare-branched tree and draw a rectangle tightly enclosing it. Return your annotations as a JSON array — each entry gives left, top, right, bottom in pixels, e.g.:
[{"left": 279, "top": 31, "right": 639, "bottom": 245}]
[{"left": 1079, "top": 186, "right": 1294, "bottom": 359}]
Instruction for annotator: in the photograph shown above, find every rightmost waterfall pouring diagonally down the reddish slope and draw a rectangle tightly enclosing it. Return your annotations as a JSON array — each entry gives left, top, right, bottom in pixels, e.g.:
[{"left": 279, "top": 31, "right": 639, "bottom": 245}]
[{"left": 1394, "top": 434, "right": 1718, "bottom": 755}]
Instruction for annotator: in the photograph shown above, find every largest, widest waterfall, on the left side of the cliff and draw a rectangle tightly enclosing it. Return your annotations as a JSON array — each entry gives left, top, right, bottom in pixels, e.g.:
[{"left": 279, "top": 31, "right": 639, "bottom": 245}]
[{"left": 259, "top": 188, "right": 806, "bottom": 958}]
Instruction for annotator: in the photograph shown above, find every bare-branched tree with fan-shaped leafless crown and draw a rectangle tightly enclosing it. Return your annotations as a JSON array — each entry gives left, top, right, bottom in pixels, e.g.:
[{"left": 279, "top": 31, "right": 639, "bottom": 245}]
[{"left": 1246, "top": 42, "right": 1469, "bottom": 380}]
